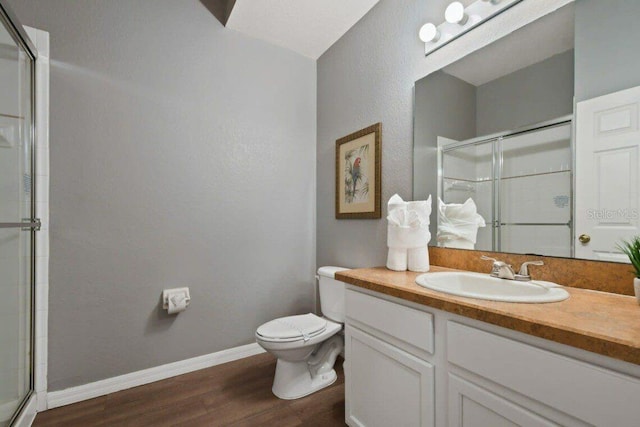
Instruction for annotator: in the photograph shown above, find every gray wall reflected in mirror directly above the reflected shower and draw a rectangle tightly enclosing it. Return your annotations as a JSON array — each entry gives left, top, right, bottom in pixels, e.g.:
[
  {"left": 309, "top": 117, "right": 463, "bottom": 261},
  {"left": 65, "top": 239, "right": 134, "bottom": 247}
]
[{"left": 476, "top": 50, "right": 574, "bottom": 136}]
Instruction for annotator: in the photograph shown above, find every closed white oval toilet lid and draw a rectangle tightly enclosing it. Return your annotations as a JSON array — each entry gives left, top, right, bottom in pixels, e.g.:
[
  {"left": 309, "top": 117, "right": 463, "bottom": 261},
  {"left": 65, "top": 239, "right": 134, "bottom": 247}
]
[{"left": 256, "top": 313, "right": 327, "bottom": 341}]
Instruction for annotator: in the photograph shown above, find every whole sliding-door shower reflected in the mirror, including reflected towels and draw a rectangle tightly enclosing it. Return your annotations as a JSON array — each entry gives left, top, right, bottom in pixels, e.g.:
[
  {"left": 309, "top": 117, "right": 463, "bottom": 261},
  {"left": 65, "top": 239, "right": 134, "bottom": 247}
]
[{"left": 438, "top": 117, "right": 573, "bottom": 257}]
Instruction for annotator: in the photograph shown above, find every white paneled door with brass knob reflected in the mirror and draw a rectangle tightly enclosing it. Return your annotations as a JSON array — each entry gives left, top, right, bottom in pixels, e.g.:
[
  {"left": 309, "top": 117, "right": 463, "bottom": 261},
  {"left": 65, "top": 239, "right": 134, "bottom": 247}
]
[{"left": 575, "top": 86, "right": 640, "bottom": 262}]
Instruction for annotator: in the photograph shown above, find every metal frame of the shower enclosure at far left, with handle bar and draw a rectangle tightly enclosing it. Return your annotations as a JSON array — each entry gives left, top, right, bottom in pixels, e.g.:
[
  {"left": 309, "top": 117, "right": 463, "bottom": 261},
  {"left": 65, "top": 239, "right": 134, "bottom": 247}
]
[{"left": 0, "top": 0, "right": 40, "bottom": 425}]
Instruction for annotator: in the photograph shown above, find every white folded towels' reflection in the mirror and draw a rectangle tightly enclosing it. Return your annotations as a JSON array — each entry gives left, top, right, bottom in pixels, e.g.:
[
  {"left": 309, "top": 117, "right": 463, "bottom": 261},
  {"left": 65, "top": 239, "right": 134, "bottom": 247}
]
[{"left": 437, "top": 198, "right": 486, "bottom": 249}]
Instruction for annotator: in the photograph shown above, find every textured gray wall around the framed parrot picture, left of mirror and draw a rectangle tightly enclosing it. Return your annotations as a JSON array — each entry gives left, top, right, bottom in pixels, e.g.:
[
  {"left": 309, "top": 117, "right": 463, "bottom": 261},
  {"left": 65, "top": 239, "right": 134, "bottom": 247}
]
[{"left": 317, "top": 0, "right": 447, "bottom": 267}]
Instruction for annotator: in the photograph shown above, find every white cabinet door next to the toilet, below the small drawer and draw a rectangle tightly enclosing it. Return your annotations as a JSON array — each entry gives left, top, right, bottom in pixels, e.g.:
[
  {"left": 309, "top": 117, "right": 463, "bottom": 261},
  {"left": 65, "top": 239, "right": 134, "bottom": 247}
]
[{"left": 345, "top": 325, "right": 435, "bottom": 427}]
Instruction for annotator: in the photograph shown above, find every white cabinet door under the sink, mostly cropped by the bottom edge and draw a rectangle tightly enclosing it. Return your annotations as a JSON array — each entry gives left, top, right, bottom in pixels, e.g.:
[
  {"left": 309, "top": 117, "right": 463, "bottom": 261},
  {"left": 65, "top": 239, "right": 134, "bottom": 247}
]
[{"left": 449, "top": 374, "right": 558, "bottom": 427}]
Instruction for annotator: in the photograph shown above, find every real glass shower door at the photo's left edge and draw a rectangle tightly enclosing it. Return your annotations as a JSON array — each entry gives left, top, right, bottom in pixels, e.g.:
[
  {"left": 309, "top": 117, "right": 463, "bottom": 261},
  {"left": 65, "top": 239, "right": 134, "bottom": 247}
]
[{"left": 0, "top": 10, "right": 35, "bottom": 426}]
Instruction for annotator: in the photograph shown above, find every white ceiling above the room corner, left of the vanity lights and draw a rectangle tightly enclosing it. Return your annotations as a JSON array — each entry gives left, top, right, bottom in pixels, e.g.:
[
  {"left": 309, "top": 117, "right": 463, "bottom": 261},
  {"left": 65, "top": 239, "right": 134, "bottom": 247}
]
[{"left": 226, "top": 0, "right": 379, "bottom": 59}]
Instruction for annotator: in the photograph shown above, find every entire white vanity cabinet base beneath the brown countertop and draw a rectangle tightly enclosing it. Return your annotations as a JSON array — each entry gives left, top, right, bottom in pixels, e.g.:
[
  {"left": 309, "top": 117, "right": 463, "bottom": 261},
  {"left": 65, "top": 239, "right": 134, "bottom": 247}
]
[{"left": 345, "top": 287, "right": 640, "bottom": 427}]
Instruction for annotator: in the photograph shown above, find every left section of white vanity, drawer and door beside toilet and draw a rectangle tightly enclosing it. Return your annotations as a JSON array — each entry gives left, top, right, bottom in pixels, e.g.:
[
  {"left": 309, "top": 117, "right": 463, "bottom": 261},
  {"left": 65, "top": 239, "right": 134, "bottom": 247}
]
[{"left": 345, "top": 291, "right": 435, "bottom": 427}]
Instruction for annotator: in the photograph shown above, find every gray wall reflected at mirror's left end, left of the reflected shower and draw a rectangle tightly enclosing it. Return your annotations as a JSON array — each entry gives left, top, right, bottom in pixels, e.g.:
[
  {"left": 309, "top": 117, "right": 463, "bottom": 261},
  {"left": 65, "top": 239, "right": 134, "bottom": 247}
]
[{"left": 413, "top": 71, "right": 476, "bottom": 237}]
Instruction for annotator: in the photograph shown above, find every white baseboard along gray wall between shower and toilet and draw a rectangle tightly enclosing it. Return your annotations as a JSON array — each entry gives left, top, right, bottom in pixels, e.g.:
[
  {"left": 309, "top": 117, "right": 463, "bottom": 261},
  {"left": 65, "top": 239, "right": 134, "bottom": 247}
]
[{"left": 47, "top": 343, "right": 264, "bottom": 409}]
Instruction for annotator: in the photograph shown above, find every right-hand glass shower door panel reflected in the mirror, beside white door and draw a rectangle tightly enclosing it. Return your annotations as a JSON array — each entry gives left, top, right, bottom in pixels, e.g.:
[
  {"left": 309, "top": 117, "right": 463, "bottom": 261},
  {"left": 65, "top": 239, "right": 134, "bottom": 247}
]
[{"left": 497, "top": 122, "right": 573, "bottom": 257}]
